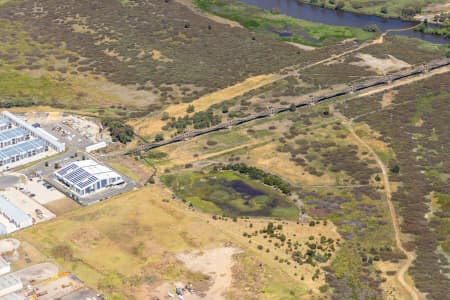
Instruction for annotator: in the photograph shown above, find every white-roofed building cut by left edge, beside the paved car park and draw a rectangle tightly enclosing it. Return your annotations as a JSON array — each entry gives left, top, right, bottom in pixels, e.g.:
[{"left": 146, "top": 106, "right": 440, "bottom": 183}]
[{"left": 0, "top": 195, "right": 33, "bottom": 234}]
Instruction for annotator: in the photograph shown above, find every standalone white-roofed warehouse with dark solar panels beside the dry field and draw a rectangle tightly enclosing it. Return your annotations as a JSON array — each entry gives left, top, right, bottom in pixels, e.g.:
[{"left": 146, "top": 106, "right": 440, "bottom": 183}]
[{"left": 55, "top": 159, "right": 124, "bottom": 197}]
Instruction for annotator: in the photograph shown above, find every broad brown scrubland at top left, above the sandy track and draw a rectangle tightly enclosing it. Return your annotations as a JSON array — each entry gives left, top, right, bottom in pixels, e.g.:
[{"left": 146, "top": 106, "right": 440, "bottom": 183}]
[{"left": 0, "top": 0, "right": 306, "bottom": 108}]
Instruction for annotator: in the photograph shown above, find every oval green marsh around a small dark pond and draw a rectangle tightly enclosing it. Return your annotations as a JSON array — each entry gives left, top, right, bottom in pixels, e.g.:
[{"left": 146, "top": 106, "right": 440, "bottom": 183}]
[{"left": 161, "top": 171, "right": 298, "bottom": 220}]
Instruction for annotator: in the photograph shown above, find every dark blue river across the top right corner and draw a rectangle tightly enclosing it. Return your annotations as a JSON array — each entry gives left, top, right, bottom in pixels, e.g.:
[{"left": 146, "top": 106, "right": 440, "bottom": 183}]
[{"left": 241, "top": 0, "right": 450, "bottom": 44}]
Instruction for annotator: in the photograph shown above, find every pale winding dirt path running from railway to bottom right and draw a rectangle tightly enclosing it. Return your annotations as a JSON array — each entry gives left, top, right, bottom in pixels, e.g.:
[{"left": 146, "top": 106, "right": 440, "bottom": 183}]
[{"left": 335, "top": 112, "right": 425, "bottom": 300}]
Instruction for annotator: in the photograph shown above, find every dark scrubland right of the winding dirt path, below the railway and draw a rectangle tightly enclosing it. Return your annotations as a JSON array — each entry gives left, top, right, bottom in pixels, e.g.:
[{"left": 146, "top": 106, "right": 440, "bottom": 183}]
[{"left": 339, "top": 73, "right": 450, "bottom": 299}]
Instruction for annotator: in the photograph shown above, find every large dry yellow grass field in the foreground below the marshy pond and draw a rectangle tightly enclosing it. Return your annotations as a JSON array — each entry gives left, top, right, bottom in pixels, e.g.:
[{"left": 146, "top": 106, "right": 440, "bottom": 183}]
[{"left": 14, "top": 186, "right": 339, "bottom": 299}]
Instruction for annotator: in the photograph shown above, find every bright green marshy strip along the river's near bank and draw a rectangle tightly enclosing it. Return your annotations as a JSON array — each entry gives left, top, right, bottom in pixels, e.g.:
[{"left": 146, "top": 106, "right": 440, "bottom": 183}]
[{"left": 195, "top": 0, "right": 374, "bottom": 46}]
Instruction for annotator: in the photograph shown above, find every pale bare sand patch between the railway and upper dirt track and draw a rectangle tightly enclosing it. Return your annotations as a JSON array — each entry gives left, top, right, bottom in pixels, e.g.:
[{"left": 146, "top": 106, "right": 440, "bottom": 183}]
[{"left": 351, "top": 53, "right": 411, "bottom": 74}]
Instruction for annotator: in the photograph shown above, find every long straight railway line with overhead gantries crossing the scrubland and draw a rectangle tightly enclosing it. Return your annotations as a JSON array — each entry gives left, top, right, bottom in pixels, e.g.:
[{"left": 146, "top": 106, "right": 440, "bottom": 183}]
[{"left": 125, "top": 58, "right": 450, "bottom": 155}]
